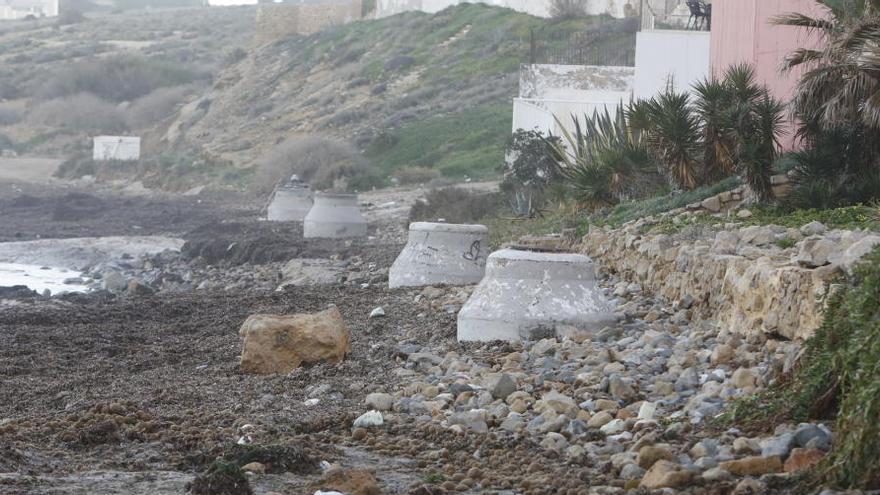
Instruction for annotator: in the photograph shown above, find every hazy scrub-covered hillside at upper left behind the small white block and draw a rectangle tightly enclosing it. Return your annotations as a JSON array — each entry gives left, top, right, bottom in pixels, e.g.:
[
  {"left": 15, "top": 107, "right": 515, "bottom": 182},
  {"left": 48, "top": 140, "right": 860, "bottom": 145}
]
[{"left": 0, "top": 7, "right": 255, "bottom": 158}]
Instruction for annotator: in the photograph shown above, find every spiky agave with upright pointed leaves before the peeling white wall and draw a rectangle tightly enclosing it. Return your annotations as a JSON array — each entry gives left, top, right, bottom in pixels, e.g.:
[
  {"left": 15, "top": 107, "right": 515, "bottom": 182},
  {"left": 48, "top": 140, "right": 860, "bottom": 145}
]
[{"left": 553, "top": 104, "right": 660, "bottom": 208}]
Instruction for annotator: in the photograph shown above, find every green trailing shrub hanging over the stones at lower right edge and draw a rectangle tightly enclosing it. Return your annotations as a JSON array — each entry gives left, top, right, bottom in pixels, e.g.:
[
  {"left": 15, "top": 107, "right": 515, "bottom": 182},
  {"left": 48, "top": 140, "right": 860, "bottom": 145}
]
[{"left": 744, "top": 249, "right": 880, "bottom": 489}]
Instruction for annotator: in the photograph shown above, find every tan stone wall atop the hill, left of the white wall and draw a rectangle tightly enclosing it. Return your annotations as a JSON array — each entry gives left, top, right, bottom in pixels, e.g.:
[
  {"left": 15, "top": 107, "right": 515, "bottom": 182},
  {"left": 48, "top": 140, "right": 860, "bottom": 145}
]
[{"left": 255, "top": 0, "right": 363, "bottom": 45}]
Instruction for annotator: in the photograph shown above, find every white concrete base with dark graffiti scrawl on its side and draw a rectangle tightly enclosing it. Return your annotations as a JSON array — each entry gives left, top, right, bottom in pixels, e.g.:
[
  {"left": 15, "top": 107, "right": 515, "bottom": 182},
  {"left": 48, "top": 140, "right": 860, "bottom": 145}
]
[{"left": 388, "top": 222, "right": 489, "bottom": 289}]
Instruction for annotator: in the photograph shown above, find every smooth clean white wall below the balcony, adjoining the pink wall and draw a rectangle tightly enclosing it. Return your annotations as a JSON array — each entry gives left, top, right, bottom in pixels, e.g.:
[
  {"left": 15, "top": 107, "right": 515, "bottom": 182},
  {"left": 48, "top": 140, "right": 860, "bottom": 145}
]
[{"left": 635, "top": 30, "right": 711, "bottom": 98}]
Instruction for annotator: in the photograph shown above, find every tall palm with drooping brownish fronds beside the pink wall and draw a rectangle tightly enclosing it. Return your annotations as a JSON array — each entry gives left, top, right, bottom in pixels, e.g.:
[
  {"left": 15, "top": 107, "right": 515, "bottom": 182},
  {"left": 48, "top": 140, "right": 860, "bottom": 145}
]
[{"left": 775, "top": 0, "right": 880, "bottom": 204}]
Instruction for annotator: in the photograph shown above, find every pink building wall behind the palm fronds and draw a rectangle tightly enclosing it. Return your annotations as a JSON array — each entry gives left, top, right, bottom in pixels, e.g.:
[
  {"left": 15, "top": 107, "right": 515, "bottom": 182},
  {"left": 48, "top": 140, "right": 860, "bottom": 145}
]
[{"left": 709, "top": 0, "right": 823, "bottom": 149}]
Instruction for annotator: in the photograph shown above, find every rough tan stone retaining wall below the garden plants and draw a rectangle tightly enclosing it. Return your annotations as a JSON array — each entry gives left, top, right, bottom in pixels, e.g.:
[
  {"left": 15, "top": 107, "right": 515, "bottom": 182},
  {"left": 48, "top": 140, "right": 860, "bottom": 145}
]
[{"left": 580, "top": 220, "right": 880, "bottom": 339}]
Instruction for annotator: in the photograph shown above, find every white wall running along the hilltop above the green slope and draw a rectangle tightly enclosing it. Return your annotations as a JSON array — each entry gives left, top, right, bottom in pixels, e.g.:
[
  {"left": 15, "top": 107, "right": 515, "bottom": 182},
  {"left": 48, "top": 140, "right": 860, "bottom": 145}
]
[{"left": 376, "top": 0, "right": 644, "bottom": 18}]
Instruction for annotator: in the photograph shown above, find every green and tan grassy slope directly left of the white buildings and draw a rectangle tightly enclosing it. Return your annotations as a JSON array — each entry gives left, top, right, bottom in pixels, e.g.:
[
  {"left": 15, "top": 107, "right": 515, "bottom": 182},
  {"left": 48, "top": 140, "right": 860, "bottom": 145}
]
[{"left": 177, "top": 4, "right": 634, "bottom": 185}]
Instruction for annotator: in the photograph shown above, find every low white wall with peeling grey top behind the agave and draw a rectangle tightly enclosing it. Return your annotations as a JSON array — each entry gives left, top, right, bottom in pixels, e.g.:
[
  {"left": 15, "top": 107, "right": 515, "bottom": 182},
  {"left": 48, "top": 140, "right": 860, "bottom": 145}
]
[{"left": 513, "top": 64, "right": 635, "bottom": 136}]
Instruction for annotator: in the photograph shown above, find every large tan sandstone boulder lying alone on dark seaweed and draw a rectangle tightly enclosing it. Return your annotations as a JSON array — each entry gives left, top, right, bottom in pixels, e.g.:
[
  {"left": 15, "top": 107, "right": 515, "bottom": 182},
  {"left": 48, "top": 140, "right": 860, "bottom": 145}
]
[{"left": 239, "top": 308, "right": 351, "bottom": 374}]
